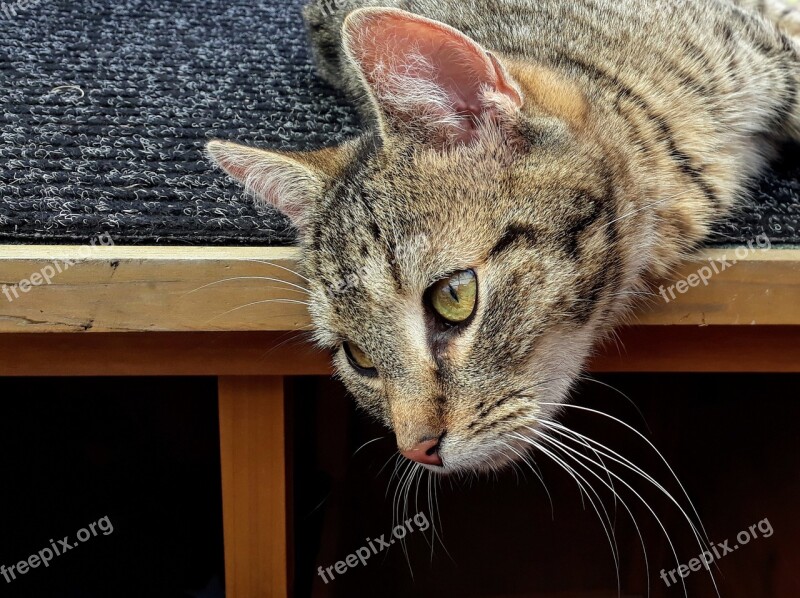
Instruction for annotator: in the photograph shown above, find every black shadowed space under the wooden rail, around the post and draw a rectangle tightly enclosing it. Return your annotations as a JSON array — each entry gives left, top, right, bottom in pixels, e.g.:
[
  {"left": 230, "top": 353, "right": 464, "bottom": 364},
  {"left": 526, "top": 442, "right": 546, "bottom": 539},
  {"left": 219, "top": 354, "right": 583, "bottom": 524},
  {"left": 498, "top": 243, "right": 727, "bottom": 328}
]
[{"left": 0, "top": 375, "right": 800, "bottom": 598}]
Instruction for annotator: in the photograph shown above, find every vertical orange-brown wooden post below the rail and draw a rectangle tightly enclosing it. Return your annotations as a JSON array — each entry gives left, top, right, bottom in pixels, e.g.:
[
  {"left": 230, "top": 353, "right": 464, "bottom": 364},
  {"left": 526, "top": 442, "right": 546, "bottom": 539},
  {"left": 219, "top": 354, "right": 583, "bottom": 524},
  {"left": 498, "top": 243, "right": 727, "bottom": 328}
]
[{"left": 219, "top": 376, "right": 289, "bottom": 598}]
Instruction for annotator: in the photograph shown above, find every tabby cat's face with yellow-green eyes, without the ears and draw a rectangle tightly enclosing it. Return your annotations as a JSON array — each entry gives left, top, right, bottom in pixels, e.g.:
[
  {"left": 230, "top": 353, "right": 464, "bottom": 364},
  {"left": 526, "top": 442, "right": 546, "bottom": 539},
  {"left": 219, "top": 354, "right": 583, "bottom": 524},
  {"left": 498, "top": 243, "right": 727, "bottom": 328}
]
[{"left": 304, "top": 135, "right": 616, "bottom": 470}]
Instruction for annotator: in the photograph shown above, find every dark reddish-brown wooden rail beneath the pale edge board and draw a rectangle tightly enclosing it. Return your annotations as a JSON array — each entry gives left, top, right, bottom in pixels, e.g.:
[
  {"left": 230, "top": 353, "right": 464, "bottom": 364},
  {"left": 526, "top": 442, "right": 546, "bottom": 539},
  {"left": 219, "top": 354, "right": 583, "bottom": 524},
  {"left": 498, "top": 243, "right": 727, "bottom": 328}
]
[{"left": 0, "top": 326, "right": 800, "bottom": 377}]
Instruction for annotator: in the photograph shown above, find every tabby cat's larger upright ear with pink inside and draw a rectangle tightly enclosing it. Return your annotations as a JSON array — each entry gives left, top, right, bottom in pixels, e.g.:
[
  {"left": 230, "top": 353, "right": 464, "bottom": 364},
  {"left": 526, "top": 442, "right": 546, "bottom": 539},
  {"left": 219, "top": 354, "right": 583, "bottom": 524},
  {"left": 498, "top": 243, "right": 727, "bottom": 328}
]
[{"left": 343, "top": 8, "right": 523, "bottom": 143}]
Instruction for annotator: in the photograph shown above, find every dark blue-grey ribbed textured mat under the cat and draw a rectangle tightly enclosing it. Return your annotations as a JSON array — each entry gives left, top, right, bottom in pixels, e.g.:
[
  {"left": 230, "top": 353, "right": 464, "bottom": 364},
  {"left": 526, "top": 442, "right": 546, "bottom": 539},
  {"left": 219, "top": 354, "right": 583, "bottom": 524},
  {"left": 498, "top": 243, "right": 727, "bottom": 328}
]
[{"left": 0, "top": 0, "right": 800, "bottom": 245}]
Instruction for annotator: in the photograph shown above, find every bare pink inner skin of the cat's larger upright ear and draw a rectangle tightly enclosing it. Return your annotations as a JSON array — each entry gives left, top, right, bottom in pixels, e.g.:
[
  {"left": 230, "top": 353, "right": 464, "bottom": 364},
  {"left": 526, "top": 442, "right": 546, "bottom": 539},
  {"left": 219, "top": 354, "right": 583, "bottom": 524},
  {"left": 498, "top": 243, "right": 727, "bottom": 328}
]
[{"left": 348, "top": 9, "right": 522, "bottom": 137}]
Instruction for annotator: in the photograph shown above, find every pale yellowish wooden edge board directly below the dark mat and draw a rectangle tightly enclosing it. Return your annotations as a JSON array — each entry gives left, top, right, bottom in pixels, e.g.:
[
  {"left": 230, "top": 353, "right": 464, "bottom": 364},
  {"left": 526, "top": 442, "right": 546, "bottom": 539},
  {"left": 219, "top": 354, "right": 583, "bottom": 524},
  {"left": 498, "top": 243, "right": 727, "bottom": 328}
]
[{"left": 0, "top": 245, "right": 800, "bottom": 333}]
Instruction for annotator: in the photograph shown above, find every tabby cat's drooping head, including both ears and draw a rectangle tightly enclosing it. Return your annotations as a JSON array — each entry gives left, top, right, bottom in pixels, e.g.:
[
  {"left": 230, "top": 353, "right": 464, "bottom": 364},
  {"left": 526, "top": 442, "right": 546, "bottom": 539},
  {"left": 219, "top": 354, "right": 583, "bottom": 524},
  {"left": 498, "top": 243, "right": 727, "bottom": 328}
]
[{"left": 209, "top": 9, "right": 626, "bottom": 472}]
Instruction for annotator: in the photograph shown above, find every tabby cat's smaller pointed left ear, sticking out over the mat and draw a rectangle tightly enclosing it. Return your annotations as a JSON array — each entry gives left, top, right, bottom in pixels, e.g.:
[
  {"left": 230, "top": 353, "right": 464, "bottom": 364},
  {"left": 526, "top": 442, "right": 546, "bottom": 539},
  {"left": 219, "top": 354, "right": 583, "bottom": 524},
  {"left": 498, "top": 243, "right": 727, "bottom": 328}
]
[{"left": 206, "top": 140, "right": 340, "bottom": 230}]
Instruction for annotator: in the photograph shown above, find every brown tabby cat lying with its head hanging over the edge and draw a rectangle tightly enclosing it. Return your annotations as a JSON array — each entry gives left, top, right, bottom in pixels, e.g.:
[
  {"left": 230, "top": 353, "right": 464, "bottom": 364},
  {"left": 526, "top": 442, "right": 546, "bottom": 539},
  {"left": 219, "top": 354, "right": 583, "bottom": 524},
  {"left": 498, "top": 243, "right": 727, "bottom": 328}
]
[{"left": 208, "top": 0, "right": 800, "bottom": 473}]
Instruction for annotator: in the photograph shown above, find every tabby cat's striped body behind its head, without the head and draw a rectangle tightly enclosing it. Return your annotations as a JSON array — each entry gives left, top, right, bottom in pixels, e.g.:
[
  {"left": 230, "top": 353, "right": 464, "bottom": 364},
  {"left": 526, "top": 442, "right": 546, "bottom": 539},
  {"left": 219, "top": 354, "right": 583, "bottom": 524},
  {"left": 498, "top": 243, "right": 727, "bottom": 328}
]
[{"left": 306, "top": 0, "right": 800, "bottom": 274}]
